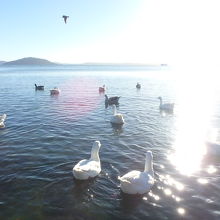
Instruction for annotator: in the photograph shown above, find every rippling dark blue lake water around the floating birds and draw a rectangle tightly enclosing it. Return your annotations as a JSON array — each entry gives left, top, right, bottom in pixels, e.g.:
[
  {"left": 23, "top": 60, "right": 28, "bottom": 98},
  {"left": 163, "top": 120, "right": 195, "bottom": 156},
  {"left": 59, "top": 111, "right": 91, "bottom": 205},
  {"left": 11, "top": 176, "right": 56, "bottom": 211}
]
[{"left": 0, "top": 66, "right": 220, "bottom": 220}]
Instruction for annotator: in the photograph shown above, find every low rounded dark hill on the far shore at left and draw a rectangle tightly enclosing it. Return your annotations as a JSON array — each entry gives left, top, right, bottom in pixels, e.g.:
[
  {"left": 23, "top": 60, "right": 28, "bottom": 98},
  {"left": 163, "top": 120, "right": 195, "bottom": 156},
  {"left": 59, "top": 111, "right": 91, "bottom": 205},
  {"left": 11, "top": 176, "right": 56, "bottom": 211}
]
[{"left": 2, "top": 57, "right": 57, "bottom": 66}]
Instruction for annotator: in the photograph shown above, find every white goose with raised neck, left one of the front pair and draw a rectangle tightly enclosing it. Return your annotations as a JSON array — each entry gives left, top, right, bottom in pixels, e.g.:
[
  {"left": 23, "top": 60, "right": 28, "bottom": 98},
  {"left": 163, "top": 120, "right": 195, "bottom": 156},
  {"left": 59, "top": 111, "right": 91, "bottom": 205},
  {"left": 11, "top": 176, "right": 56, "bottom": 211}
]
[{"left": 73, "top": 141, "right": 101, "bottom": 180}]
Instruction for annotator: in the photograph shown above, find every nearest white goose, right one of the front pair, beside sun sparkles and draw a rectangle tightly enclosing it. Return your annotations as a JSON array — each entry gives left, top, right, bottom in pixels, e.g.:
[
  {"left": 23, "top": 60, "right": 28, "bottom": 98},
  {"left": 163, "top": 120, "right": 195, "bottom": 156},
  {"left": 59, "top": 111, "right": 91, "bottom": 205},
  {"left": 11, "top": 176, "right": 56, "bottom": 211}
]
[{"left": 118, "top": 151, "right": 154, "bottom": 194}]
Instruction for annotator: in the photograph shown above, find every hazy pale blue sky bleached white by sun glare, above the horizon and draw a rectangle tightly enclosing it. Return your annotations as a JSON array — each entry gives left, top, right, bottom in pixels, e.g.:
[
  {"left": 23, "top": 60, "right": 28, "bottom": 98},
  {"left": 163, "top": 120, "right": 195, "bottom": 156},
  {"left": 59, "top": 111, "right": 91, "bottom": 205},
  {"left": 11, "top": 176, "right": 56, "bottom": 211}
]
[{"left": 0, "top": 0, "right": 220, "bottom": 64}]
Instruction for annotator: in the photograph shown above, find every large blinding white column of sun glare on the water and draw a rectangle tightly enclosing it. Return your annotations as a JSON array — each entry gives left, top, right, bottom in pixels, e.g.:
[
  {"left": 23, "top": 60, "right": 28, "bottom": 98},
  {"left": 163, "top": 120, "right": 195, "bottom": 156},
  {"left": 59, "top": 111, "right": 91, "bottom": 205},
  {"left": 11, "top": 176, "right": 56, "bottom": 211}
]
[{"left": 168, "top": 73, "right": 214, "bottom": 176}]
